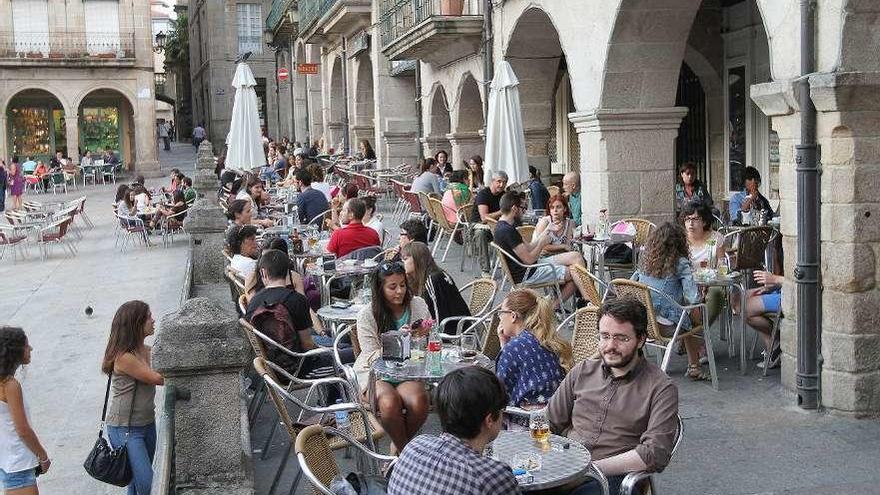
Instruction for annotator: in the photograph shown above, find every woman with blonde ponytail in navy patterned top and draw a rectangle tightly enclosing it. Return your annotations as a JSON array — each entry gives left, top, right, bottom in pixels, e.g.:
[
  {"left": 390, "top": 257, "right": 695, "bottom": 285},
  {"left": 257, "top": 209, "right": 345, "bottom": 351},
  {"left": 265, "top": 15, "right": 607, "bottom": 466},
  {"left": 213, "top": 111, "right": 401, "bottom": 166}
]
[{"left": 495, "top": 289, "right": 572, "bottom": 406}]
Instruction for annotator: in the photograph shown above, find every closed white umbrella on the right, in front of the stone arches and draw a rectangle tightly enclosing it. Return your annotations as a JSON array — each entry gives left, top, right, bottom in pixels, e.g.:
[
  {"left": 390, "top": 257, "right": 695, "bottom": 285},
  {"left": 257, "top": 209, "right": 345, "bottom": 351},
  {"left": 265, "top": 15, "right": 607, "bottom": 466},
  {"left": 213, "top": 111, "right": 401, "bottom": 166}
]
[{"left": 484, "top": 60, "right": 529, "bottom": 184}]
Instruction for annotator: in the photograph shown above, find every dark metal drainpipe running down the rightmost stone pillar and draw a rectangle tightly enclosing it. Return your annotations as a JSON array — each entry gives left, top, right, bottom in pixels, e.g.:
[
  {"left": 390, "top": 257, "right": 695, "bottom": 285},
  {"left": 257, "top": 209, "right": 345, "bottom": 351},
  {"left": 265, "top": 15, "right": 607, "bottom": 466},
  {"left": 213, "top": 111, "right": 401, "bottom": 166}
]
[{"left": 794, "top": 0, "right": 822, "bottom": 409}]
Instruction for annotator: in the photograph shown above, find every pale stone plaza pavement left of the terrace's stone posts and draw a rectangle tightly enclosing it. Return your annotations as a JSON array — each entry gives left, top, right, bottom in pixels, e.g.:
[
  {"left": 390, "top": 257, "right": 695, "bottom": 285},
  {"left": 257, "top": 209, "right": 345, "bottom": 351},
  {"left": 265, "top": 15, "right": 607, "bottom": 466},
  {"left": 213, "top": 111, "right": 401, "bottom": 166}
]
[{"left": 0, "top": 144, "right": 195, "bottom": 495}]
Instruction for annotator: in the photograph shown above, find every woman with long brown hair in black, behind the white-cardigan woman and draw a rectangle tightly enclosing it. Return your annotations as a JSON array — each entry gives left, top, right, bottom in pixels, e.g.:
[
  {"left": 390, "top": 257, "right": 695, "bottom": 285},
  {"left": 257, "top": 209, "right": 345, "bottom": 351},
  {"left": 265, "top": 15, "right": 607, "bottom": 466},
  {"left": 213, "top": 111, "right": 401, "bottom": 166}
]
[{"left": 400, "top": 241, "right": 471, "bottom": 333}]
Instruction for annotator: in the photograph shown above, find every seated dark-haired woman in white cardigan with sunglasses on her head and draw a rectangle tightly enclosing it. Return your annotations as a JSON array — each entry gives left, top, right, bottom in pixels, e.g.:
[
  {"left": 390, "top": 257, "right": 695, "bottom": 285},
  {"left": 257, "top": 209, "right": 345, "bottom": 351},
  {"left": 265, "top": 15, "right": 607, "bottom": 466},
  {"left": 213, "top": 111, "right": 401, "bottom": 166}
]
[{"left": 354, "top": 261, "right": 431, "bottom": 452}]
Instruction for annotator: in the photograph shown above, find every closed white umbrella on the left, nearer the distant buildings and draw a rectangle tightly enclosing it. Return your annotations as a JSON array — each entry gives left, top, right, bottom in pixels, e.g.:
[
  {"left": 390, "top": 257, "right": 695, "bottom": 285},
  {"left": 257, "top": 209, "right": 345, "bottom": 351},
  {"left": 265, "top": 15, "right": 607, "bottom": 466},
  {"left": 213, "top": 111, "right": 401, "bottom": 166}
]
[{"left": 226, "top": 62, "right": 266, "bottom": 171}]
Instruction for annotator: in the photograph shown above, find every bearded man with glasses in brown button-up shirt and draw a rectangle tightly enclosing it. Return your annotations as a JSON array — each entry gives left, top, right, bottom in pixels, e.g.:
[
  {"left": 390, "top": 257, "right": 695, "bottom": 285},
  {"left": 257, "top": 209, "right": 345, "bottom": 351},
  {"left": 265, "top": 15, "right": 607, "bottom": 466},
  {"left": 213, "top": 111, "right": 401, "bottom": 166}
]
[{"left": 547, "top": 298, "right": 678, "bottom": 495}]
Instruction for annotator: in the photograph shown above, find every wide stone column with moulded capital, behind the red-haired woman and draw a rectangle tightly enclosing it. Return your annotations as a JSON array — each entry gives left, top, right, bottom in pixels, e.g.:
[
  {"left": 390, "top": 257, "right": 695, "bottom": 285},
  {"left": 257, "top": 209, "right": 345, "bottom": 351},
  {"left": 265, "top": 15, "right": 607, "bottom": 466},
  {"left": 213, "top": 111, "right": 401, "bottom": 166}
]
[{"left": 568, "top": 107, "right": 687, "bottom": 228}]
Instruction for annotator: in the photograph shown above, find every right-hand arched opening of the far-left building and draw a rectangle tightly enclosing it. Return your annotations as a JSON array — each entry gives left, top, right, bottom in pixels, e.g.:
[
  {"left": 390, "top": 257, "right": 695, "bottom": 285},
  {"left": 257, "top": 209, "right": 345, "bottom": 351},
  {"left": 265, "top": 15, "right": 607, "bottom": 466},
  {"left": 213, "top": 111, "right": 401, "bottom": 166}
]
[{"left": 76, "top": 84, "right": 138, "bottom": 169}]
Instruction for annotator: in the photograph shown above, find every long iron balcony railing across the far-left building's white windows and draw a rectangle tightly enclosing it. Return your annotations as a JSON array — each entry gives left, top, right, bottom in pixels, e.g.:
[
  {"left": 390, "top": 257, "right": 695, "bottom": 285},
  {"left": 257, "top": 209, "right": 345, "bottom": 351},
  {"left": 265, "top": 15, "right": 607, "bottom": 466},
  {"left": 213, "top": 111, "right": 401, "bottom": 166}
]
[{"left": 0, "top": 31, "right": 135, "bottom": 61}]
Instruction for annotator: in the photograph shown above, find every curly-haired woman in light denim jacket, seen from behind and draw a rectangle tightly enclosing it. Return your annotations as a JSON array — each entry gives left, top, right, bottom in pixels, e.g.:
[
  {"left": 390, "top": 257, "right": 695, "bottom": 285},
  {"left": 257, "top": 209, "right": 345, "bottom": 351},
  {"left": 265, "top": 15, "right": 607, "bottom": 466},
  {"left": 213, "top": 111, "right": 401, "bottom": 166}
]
[{"left": 632, "top": 222, "right": 707, "bottom": 380}]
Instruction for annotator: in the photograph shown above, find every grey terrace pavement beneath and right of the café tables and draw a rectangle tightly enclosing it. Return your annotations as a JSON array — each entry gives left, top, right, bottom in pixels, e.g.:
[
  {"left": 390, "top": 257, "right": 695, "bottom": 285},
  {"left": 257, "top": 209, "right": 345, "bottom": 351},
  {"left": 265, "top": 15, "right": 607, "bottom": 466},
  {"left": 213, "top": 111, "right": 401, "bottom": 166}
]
[{"left": 251, "top": 195, "right": 880, "bottom": 495}]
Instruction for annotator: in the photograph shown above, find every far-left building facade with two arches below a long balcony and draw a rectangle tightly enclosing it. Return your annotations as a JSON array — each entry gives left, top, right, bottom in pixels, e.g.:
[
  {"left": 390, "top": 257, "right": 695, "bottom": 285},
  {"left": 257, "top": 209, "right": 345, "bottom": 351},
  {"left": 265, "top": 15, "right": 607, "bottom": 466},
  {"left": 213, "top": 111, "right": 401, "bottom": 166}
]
[{"left": 0, "top": 0, "right": 159, "bottom": 174}]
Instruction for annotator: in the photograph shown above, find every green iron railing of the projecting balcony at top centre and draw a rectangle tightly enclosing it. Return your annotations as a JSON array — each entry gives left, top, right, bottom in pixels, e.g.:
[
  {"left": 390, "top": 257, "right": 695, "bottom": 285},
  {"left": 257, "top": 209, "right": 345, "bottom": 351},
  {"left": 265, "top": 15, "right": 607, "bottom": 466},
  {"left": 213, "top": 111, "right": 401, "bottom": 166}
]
[{"left": 379, "top": 0, "right": 483, "bottom": 47}]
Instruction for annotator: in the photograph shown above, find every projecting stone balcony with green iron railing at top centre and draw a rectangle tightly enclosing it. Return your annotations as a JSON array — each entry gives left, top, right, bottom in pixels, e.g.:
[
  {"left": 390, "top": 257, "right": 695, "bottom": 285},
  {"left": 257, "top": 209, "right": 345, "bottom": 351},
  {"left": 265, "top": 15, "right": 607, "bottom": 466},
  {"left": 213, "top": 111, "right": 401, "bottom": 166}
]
[{"left": 379, "top": 0, "right": 483, "bottom": 65}]
